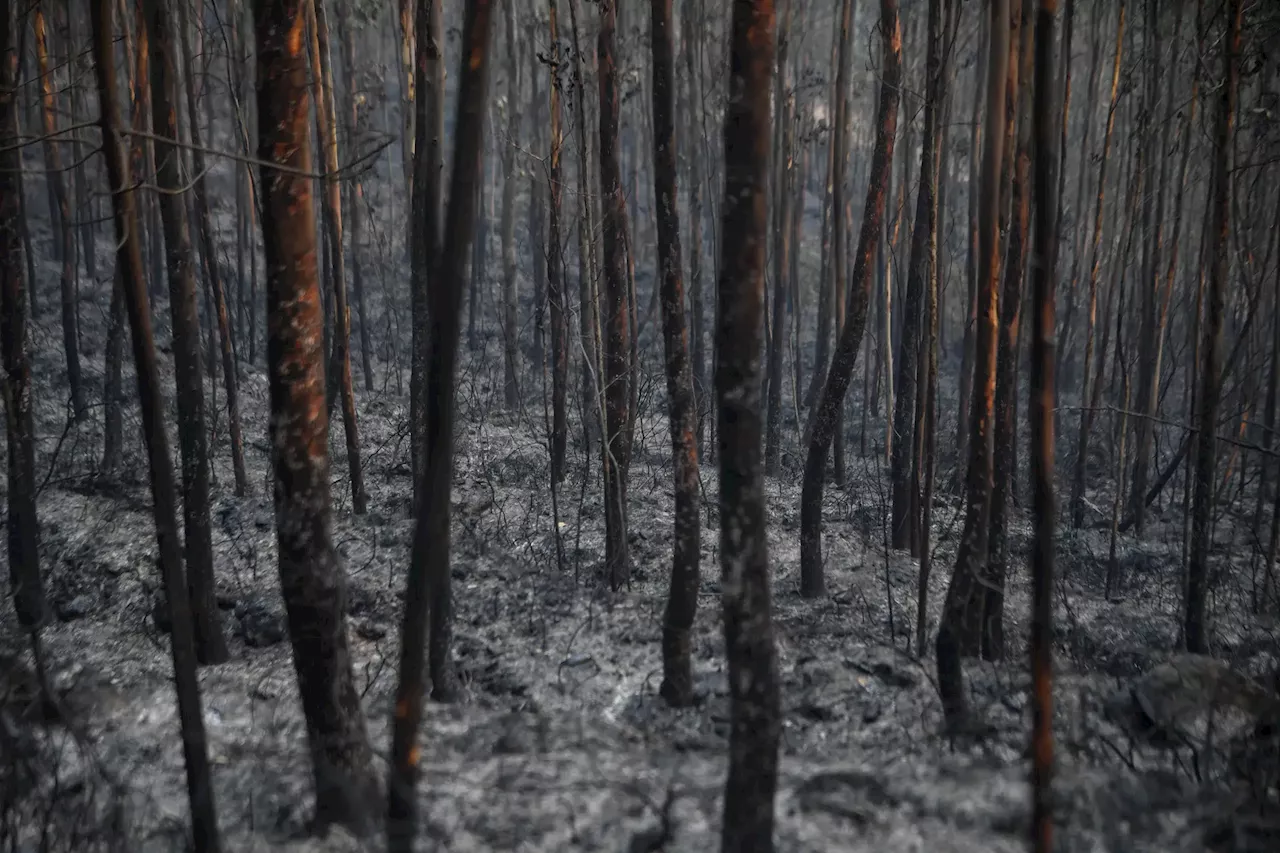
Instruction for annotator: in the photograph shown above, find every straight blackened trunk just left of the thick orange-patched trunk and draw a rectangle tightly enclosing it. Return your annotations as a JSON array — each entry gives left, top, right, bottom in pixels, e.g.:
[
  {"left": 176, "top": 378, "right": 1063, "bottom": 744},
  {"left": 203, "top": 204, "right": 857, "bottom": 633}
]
[{"left": 142, "top": 0, "right": 229, "bottom": 663}]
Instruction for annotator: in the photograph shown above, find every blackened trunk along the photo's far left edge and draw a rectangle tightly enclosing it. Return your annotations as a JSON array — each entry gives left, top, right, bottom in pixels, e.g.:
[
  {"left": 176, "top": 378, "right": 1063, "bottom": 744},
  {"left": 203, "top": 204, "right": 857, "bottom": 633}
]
[{"left": 0, "top": 3, "right": 47, "bottom": 631}]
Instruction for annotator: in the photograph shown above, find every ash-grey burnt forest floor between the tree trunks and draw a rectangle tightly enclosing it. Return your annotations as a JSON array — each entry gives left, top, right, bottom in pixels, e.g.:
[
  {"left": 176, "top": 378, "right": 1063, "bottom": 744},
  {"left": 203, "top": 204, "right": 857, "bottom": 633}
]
[{"left": 0, "top": 294, "right": 1275, "bottom": 853}]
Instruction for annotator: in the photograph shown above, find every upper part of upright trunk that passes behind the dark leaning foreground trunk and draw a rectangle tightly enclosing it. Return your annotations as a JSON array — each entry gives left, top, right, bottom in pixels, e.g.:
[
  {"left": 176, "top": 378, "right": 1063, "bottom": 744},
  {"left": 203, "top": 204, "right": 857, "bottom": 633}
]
[{"left": 410, "top": 0, "right": 450, "bottom": 517}]
